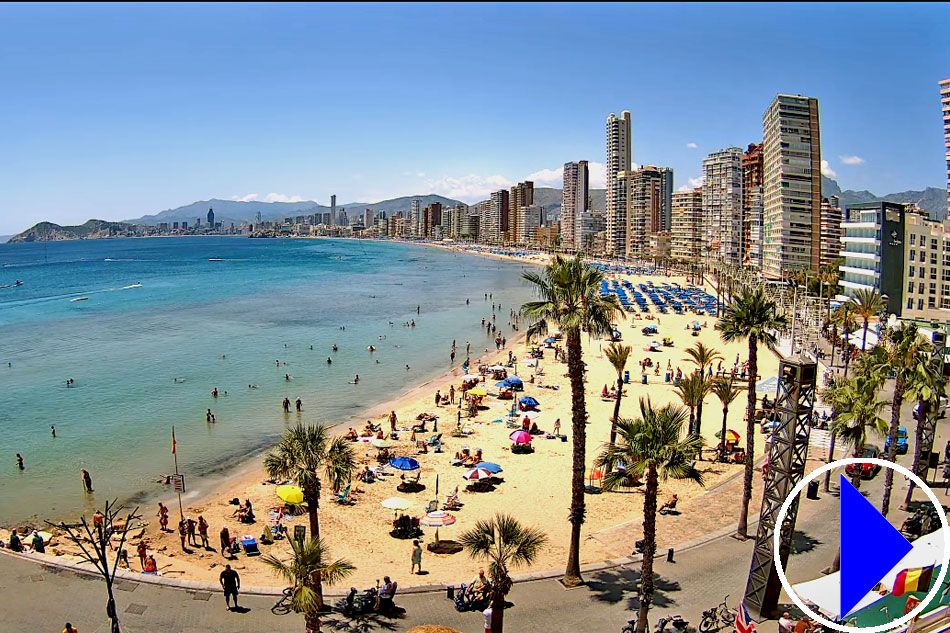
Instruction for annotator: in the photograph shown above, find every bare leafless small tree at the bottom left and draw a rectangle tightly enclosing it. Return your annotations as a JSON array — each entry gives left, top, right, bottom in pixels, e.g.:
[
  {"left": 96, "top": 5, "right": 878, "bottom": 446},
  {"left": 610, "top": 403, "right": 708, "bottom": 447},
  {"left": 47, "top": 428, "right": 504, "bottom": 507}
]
[{"left": 46, "top": 500, "right": 142, "bottom": 633}]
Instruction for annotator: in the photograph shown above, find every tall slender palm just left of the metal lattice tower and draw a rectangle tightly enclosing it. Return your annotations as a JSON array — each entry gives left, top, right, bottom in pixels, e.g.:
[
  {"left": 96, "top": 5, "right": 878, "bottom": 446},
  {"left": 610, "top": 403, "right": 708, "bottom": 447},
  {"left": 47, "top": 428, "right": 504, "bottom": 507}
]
[{"left": 716, "top": 287, "right": 788, "bottom": 538}]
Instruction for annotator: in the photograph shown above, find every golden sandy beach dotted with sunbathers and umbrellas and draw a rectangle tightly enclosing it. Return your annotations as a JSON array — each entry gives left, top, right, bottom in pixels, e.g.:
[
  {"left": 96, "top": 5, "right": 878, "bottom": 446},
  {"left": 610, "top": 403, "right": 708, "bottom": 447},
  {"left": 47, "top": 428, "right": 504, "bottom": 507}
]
[{"left": 14, "top": 255, "right": 778, "bottom": 586}]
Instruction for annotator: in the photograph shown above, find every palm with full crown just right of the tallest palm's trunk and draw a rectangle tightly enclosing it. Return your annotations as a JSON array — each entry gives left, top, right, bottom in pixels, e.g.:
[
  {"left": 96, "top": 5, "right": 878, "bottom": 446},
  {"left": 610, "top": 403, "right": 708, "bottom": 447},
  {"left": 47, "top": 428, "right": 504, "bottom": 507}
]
[{"left": 596, "top": 398, "right": 703, "bottom": 633}]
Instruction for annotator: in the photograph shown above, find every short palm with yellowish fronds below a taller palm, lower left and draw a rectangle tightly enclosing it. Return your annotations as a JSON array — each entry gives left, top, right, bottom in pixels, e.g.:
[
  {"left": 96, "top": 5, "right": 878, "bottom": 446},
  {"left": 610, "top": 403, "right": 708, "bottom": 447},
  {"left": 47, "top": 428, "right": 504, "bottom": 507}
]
[{"left": 261, "top": 539, "right": 356, "bottom": 632}]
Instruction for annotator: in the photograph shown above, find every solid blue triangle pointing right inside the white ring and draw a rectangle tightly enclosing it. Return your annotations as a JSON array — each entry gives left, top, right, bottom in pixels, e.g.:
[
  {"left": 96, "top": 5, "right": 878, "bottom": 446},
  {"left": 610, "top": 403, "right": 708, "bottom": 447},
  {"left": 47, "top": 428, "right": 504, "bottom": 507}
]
[{"left": 838, "top": 475, "right": 913, "bottom": 618}]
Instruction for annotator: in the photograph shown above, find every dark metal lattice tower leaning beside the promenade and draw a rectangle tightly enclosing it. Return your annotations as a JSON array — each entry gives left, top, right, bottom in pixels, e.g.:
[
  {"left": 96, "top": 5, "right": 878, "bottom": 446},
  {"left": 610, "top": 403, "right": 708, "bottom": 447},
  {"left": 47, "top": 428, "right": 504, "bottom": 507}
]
[{"left": 745, "top": 358, "right": 818, "bottom": 616}]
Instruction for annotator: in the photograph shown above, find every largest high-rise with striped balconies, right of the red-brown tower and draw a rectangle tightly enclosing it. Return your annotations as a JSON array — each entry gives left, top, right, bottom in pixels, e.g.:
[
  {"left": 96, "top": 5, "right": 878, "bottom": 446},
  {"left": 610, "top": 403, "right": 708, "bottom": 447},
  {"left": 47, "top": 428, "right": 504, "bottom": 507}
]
[{"left": 762, "top": 95, "right": 821, "bottom": 279}]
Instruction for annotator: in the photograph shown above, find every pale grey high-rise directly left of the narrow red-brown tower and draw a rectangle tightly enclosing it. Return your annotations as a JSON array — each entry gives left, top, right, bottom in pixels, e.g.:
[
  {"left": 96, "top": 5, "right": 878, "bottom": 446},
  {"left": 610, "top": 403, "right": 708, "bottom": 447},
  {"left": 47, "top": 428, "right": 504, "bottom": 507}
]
[{"left": 703, "top": 147, "right": 743, "bottom": 265}]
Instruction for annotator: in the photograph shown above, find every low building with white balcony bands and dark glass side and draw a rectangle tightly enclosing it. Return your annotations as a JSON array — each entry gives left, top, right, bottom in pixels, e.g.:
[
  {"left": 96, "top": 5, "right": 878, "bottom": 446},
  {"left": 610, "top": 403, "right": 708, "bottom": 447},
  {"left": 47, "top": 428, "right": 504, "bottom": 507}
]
[{"left": 838, "top": 202, "right": 918, "bottom": 316}]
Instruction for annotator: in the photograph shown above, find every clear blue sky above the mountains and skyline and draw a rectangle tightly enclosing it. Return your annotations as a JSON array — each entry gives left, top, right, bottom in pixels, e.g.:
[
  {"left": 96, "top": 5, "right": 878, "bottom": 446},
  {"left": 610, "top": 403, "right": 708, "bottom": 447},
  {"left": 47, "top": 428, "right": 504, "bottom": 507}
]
[{"left": 0, "top": 3, "right": 950, "bottom": 233}]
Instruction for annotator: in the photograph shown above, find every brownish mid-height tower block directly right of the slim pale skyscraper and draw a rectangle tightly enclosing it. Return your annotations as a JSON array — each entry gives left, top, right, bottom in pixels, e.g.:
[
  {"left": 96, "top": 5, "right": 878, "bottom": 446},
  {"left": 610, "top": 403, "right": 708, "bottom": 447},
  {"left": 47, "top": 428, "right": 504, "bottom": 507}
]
[{"left": 628, "top": 165, "right": 665, "bottom": 260}]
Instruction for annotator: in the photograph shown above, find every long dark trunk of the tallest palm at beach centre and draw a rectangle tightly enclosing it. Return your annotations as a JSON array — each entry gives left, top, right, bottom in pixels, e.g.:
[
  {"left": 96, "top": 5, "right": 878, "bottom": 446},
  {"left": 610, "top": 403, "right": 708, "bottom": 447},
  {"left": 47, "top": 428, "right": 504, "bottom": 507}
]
[{"left": 561, "top": 329, "right": 587, "bottom": 587}]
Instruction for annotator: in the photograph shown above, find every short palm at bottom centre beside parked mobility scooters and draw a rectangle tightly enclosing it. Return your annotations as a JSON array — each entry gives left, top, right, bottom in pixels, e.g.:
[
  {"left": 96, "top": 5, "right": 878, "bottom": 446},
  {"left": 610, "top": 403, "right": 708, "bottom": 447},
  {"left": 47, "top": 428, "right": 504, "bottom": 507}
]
[{"left": 459, "top": 514, "right": 548, "bottom": 633}]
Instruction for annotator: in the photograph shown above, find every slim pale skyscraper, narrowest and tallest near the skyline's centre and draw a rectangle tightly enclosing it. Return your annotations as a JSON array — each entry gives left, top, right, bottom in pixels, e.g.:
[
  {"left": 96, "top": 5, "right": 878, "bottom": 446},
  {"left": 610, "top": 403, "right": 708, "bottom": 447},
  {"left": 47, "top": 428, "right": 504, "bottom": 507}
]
[{"left": 605, "top": 110, "right": 632, "bottom": 255}]
